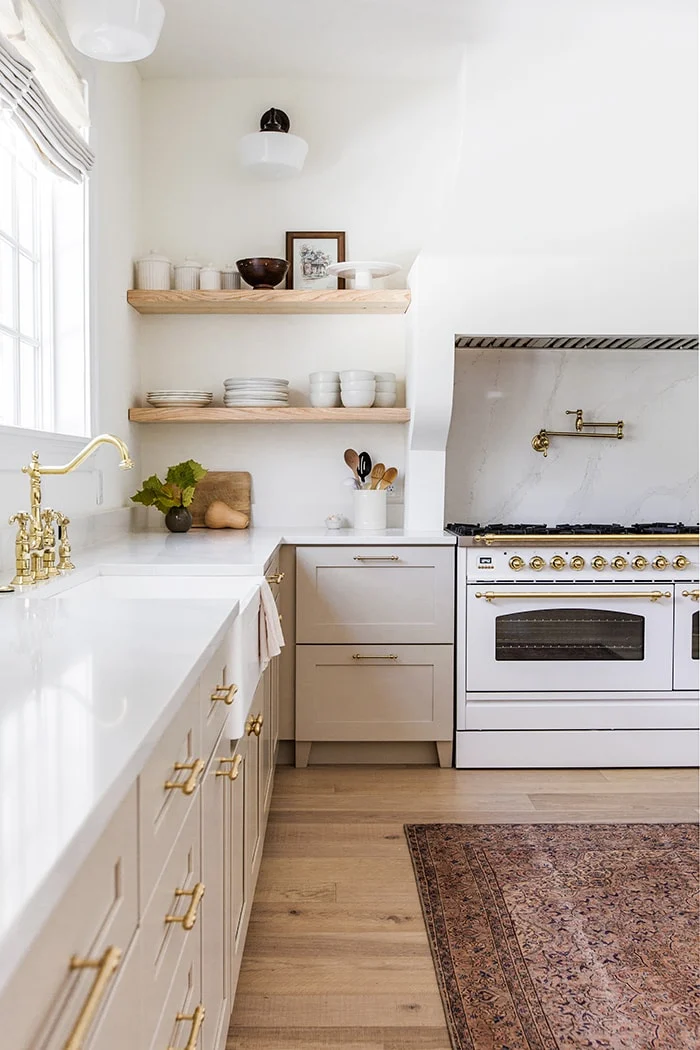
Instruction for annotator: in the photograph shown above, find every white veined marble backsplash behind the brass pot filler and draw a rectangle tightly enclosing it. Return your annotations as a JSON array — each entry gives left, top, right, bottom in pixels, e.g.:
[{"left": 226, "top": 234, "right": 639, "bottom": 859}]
[{"left": 445, "top": 350, "right": 698, "bottom": 524}]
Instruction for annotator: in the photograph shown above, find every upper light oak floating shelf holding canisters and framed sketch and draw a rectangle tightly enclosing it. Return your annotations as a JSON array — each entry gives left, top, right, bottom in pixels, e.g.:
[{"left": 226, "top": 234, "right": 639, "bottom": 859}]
[{"left": 126, "top": 288, "right": 410, "bottom": 314}]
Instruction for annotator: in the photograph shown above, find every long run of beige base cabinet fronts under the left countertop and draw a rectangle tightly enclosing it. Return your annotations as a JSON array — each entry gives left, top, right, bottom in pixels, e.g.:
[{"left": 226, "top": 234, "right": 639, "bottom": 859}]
[{"left": 0, "top": 596, "right": 285, "bottom": 1050}]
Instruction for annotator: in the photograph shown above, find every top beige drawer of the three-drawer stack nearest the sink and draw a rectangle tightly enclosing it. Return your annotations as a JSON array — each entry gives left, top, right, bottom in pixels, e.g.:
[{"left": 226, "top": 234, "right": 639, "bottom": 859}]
[{"left": 139, "top": 686, "right": 204, "bottom": 914}]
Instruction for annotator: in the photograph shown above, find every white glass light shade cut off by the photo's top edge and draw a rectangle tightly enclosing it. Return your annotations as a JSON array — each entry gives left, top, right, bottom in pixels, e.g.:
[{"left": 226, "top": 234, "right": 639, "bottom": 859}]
[{"left": 63, "top": 0, "right": 165, "bottom": 62}]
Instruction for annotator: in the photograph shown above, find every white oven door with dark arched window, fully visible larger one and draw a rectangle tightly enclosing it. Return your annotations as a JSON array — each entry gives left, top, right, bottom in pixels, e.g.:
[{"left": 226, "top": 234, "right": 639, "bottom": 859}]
[{"left": 467, "top": 583, "right": 674, "bottom": 692}]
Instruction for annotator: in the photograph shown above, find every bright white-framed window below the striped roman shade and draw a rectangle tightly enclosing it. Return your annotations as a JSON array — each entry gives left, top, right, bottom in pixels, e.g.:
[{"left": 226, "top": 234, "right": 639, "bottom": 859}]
[{"left": 0, "top": 119, "right": 89, "bottom": 435}]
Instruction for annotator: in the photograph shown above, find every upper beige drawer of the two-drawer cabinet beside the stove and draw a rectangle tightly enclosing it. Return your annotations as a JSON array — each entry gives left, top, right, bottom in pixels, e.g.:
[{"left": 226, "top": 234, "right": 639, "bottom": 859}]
[{"left": 297, "top": 546, "right": 454, "bottom": 645}]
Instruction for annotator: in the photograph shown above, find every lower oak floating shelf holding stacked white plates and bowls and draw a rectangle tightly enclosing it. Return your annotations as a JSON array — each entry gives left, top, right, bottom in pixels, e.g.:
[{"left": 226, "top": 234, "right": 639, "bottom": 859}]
[{"left": 129, "top": 407, "right": 410, "bottom": 423}]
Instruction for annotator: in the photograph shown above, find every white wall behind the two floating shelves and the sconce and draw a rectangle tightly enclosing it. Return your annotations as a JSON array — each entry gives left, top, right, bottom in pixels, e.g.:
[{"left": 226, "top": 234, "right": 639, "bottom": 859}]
[{"left": 140, "top": 80, "right": 455, "bottom": 524}]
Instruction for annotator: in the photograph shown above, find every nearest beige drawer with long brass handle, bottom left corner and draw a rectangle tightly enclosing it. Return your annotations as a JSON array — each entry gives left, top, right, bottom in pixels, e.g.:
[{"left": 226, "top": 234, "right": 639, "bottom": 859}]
[{"left": 0, "top": 786, "right": 139, "bottom": 1050}]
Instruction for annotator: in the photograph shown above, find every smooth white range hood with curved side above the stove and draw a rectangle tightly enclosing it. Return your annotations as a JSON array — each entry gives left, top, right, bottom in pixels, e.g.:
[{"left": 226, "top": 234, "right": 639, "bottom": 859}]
[{"left": 407, "top": 0, "right": 698, "bottom": 527}]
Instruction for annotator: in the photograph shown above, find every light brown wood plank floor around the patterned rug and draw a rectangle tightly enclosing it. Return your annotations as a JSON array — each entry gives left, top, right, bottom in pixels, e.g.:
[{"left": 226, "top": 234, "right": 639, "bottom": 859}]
[{"left": 227, "top": 767, "right": 698, "bottom": 1050}]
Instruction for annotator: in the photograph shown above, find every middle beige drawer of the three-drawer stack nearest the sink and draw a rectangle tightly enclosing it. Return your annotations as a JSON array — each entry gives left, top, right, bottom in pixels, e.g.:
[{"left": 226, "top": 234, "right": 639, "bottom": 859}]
[{"left": 141, "top": 789, "right": 203, "bottom": 1031}]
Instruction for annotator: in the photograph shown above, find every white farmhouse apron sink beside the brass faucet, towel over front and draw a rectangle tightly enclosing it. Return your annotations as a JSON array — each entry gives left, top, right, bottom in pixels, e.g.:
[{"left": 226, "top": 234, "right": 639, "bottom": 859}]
[{"left": 38, "top": 573, "right": 262, "bottom": 740}]
